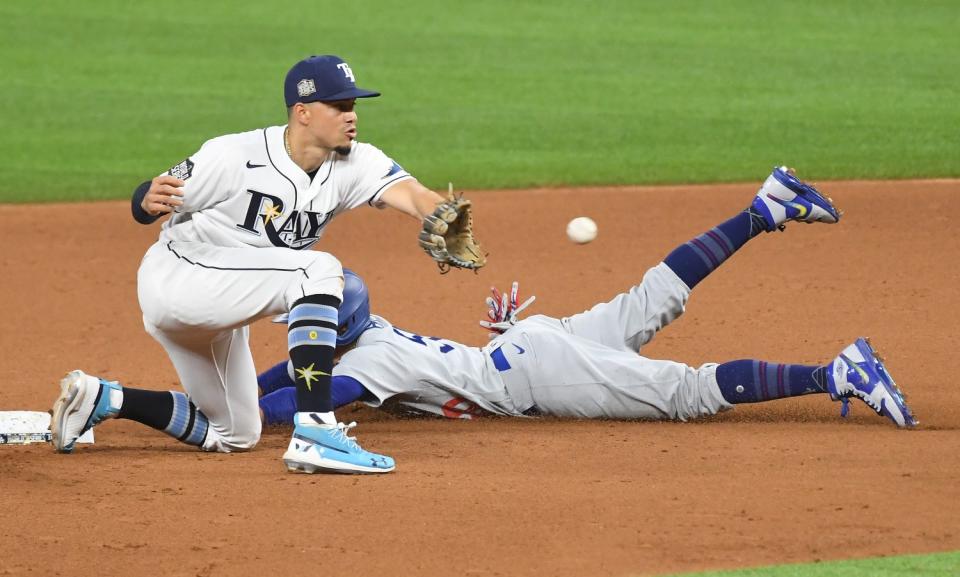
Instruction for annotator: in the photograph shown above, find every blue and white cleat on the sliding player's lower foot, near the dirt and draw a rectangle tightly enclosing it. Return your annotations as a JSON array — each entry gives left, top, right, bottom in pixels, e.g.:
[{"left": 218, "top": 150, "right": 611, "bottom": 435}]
[{"left": 827, "top": 338, "right": 918, "bottom": 427}]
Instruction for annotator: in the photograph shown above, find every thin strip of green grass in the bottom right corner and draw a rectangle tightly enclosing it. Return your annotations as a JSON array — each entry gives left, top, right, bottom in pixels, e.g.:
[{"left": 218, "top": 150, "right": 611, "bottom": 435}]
[{"left": 675, "top": 552, "right": 960, "bottom": 577}]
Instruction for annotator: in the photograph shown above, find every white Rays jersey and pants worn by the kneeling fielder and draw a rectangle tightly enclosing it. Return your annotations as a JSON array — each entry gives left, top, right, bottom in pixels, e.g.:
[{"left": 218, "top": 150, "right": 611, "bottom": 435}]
[{"left": 138, "top": 126, "right": 412, "bottom": 451}]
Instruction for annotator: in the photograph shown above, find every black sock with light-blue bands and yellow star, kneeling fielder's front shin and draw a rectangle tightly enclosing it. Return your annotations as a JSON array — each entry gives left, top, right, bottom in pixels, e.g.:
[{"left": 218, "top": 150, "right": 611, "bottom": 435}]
[{"left": 287, "top": 295, "right": 340, "bottom": 413}]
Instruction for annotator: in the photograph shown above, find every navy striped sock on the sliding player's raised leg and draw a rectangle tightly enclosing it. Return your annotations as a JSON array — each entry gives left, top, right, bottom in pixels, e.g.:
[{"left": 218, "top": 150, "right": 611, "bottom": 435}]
[{"left": 663, "top": 208, "right": 766, "bottom": 288}]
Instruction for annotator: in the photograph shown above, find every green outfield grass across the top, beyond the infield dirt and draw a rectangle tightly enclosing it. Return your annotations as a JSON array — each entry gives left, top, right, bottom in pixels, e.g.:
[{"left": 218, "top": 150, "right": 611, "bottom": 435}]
[{"left": 0, "top": 0, "right": 960, "bottom": 201}]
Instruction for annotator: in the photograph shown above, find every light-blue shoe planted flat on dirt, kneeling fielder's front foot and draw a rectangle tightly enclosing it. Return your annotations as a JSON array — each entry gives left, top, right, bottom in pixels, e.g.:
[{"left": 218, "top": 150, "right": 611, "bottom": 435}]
[{"left": 283, "top": 413, "right": 396, "bottom": 473}]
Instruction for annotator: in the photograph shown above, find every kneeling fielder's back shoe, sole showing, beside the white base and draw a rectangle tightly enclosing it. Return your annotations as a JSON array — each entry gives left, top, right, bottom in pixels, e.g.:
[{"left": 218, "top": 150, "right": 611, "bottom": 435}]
[{"left": 50, "top": 371, "right": 123, "bottom": 453}]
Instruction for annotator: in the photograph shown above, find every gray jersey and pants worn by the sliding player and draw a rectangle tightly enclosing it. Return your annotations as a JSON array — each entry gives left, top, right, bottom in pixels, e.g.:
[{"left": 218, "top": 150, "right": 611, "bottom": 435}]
[{"left": 334, "top": 263, "right": 732, "bottom": 420}]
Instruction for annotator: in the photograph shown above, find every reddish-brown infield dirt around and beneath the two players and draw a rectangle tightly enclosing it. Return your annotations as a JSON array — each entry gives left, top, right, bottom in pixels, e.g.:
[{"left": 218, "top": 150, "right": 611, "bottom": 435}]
[{"left": 0, "top": 180, "right": 960, "bottom": 577}]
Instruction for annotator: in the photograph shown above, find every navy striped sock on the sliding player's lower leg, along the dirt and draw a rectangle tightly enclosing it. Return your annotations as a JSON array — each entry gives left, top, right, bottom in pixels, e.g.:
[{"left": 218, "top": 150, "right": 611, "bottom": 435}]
[{"left": 717, "top": 359, "right": 827, "bottom": 405}]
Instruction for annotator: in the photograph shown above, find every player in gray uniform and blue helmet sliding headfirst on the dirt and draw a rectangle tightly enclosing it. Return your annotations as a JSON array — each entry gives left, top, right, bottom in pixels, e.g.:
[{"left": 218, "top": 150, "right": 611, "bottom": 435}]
[{"left": 259, "top": 168, "right": 916, "bottom": 427}]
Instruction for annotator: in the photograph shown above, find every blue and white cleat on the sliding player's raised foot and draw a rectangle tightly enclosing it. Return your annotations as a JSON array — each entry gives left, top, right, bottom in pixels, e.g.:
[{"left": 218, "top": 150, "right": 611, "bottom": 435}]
[{"left": 752, "top": 166, "right": 843, "bottom": 232}]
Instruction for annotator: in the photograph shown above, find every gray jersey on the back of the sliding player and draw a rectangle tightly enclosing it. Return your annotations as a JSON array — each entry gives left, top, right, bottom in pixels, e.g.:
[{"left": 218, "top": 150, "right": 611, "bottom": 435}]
[{"left": 333, "top": 315, "right": 517, "bottom": 419}]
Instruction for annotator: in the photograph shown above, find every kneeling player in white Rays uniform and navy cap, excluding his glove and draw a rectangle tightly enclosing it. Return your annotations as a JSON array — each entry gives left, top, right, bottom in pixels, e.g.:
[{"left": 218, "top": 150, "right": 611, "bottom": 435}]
[{"left": 52, "top": 55, "right": 464, "bottom": 473}]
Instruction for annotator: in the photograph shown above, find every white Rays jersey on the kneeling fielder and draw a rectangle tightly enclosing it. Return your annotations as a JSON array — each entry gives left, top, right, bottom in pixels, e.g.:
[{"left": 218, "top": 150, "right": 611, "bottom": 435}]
[{"left": 160, "top": 126, "right": 412, "bottom": 250}]
